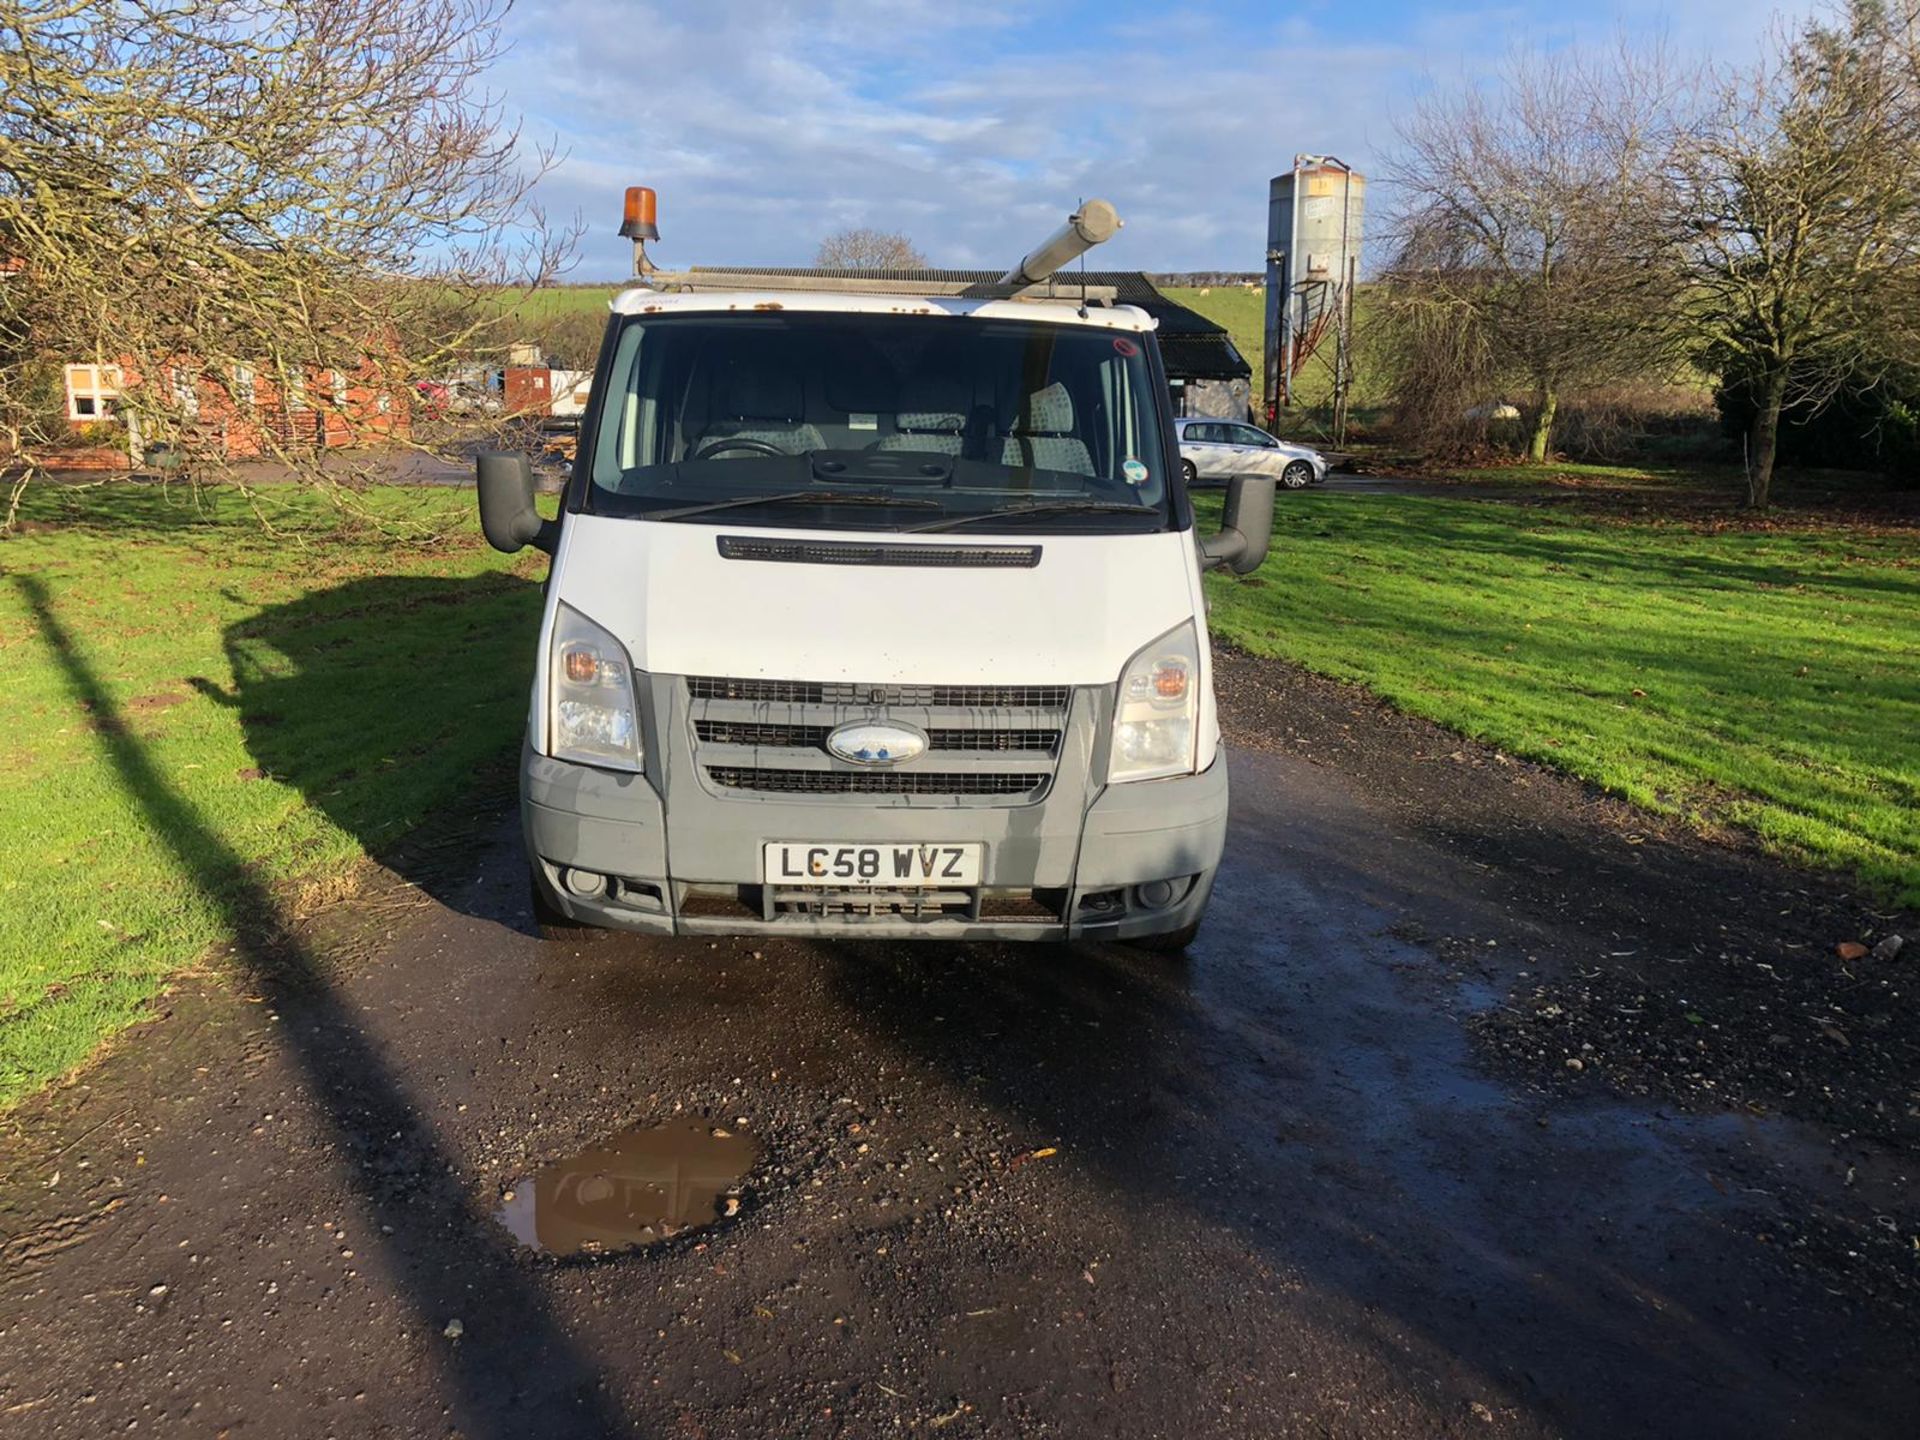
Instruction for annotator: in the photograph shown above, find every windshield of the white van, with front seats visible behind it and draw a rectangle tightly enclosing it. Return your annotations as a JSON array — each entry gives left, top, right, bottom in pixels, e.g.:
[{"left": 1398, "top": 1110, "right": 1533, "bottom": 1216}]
[{"left": 584, "top": 311, "right": 1173, "bottom": 534}]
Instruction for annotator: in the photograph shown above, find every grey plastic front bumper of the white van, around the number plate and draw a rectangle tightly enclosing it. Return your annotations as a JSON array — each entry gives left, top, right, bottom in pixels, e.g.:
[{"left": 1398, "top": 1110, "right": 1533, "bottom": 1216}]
[{"left": 520, "top": 749, "right": 1227, "bottom": 941}]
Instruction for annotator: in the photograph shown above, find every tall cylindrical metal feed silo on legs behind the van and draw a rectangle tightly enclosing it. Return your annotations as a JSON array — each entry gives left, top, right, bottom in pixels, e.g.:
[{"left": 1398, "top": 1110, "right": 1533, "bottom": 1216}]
[{"left": 1265, "top": 156, "right": 1367, "bottom": 434}]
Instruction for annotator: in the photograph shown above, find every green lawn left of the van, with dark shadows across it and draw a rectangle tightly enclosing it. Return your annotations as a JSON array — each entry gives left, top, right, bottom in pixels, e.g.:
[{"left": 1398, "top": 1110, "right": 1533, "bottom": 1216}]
[{"left": 0, "top": 486, "right": 543, "bottom": 1108}]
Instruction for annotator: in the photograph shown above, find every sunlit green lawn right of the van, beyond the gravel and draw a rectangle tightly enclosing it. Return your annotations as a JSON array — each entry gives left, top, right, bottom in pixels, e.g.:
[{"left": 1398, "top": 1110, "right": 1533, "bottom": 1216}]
[{"left": 1208, "top": 495, "right": 1920, "bottom": 904}]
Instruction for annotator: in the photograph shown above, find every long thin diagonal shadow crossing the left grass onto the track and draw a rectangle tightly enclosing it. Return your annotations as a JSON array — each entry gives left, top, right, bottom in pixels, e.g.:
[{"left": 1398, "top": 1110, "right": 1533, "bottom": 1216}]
[{"left": 13, "top": 574, "right": 636, "bottom": 1438}]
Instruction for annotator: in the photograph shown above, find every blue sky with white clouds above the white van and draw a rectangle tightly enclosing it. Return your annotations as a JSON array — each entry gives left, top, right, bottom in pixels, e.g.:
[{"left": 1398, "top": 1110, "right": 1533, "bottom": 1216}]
[{"left": 490, "top": 0, "right": 1812, "bottom": 280}]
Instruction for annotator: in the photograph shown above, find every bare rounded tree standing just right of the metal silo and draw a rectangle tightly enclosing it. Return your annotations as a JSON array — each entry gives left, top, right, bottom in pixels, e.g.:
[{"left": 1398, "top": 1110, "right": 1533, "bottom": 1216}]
[{"left": 1382, "top": 44, "right": 1680, "bottom": 461}]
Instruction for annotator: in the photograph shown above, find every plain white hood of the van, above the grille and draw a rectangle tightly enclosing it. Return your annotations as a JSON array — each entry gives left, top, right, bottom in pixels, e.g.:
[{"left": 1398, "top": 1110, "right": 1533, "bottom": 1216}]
[{"left": 553, "top": 513, "right": 1200, "bottom": 685}]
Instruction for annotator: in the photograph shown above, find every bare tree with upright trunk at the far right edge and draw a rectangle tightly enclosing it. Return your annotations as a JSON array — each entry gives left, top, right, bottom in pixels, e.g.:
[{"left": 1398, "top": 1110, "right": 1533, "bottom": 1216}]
[{"left": 1674, "top": 0, "right": 1920, "bottom": 507}]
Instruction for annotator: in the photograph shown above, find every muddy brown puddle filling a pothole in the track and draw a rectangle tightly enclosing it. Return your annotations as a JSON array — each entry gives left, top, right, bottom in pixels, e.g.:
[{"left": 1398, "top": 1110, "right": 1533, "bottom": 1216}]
[{"left": 497, "top": 1123, "right": 760, "bottom": 1256}]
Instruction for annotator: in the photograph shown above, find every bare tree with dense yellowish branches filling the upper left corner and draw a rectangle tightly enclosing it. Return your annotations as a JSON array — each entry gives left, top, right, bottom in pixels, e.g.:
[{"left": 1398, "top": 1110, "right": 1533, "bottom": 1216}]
[{"left": 0, "top": 0, "right": 572, "bottom": 524}]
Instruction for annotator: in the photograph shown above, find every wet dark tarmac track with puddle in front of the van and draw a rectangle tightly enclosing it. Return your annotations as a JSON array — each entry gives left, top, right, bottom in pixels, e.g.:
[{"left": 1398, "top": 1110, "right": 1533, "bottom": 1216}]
[{"left": 0, "top": 718, "right": 1920, "bottom": 1440}]
